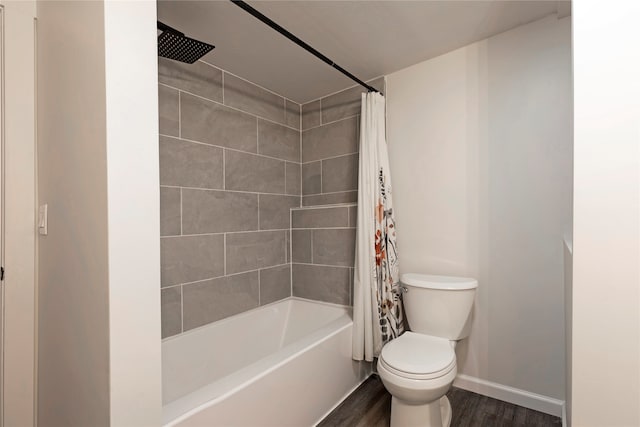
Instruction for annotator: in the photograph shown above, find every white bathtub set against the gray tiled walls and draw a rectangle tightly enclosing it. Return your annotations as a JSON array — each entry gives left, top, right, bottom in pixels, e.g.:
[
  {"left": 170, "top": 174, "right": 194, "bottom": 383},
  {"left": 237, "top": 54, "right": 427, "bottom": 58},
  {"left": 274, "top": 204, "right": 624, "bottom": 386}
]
[{"left": 162, "top": 298, "right": 370, "bottom": 427}]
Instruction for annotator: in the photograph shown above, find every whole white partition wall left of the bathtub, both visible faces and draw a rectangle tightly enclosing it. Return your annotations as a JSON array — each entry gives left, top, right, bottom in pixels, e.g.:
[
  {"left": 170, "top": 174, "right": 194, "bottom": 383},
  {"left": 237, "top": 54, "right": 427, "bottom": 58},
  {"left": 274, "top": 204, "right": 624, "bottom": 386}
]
[{"left": 37, "top": 1, "right": 161, "bottom": 426}]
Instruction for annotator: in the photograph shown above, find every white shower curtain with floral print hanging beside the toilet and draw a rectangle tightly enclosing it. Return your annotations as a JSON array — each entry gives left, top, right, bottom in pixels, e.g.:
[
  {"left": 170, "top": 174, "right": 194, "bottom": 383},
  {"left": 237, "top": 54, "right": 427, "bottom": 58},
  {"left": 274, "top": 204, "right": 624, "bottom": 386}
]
[{"left": 353, "top": 92, "right": 404, "bottom": 362}]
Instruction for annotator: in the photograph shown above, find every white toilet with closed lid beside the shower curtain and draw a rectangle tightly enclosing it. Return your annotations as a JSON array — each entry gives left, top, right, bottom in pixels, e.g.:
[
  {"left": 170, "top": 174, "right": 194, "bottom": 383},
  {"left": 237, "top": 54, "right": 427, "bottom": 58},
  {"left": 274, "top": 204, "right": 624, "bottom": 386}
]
[{"left": 378, "top": 274, "right": 478, "bottom": 427}]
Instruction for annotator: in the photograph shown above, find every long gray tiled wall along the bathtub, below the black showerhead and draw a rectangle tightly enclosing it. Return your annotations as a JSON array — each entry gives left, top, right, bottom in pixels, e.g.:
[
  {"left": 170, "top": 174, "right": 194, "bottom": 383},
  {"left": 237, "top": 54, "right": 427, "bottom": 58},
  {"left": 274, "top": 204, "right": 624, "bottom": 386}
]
[{"left": 158, "top": 58, "right": 302, "bottom": 337}]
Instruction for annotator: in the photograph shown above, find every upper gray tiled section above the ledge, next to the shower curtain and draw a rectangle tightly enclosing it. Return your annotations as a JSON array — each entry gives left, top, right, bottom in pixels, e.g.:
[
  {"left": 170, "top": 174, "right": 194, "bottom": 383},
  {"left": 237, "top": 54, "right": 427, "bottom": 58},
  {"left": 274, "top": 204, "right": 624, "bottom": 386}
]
[{"left": 302, "top": 78, "right": 384, "bottom": 206}]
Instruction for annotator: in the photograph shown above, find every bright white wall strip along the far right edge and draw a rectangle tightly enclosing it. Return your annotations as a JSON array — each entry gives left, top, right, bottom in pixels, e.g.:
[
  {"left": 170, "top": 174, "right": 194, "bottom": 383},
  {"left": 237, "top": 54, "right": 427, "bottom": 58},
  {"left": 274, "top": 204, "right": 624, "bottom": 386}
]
[{"left": 571, "top": 0, "right": 640, "bottom": 426}]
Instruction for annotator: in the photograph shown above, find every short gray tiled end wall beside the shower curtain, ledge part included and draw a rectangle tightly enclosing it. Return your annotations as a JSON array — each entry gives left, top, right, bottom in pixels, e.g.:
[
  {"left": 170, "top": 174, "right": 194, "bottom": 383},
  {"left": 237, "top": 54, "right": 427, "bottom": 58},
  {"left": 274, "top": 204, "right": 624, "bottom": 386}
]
[{"left": 291, "top": 78, "right": 384, "bottom": 305}]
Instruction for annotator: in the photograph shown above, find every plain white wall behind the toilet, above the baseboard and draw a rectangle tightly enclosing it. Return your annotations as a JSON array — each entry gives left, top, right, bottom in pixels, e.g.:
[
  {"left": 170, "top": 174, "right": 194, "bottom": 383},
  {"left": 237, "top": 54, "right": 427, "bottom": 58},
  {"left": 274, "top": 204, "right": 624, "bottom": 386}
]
[{"left": 387, "top": 16, "right": 572, "bottom": 413}]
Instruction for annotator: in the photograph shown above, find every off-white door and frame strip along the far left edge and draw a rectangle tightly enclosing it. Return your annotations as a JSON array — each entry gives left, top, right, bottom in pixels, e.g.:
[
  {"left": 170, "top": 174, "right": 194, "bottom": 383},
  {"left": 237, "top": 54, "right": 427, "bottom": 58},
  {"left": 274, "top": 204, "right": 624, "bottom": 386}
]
[{"left": 0, "top": 0, "right": 36, "bottom": 427}]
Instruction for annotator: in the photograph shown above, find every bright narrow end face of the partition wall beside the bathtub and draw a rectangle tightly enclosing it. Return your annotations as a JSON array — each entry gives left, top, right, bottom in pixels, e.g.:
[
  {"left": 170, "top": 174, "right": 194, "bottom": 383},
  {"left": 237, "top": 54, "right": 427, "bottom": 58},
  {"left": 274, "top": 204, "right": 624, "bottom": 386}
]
[{"left": 104, "top": 1, "right": 162, "bottom": 426}]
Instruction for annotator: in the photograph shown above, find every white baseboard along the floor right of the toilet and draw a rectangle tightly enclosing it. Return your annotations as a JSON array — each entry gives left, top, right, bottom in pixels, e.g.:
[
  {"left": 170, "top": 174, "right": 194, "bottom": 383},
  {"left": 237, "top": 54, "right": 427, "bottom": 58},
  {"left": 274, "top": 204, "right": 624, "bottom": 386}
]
[{"left": 453, "top": 374, "right": 564, "bottom": 418}]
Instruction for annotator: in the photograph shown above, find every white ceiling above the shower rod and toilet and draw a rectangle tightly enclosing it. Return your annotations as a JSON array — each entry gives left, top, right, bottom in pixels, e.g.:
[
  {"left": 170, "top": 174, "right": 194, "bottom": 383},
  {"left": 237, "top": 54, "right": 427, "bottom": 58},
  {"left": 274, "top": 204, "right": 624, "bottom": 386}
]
[{"left": 158, "top": 0, "right": 570, "bottom": 103}]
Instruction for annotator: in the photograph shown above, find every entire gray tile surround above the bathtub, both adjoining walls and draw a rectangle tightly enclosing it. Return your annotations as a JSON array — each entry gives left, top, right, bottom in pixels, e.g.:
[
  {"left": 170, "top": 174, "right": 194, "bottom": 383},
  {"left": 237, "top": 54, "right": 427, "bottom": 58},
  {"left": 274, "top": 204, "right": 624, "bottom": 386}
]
[{"left": 158, "top": 59, "right": 382, "bottom": 337}]
